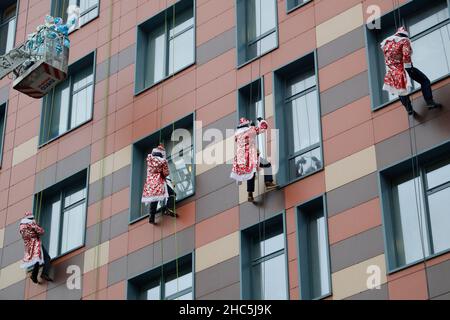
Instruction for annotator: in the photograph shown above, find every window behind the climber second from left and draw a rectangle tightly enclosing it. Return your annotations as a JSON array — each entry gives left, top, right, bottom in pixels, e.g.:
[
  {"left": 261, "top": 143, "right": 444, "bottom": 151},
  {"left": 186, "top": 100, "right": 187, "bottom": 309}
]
[{"left": 131, "top": 115, "right": 195, "bottom": 220}]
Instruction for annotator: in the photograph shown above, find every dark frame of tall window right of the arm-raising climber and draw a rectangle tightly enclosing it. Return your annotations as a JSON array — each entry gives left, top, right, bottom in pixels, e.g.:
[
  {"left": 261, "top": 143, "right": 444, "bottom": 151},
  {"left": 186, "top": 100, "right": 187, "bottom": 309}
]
[{"left": 272, "top": 49, "right": 325, "bottom": 188}]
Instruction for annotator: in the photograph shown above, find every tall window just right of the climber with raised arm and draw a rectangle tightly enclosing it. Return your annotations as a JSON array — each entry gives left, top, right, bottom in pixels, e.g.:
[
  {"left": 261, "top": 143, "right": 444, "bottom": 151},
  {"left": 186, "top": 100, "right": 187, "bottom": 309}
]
[{"left": 274, "top": 53, "right": 323, "bottom": 184}]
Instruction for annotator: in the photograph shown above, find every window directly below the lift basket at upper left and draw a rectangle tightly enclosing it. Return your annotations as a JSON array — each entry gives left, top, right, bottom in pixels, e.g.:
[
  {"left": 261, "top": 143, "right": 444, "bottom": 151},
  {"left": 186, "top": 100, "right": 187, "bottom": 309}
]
[{"left": 40, "top": 53, "right": 95, "bottom": 144}]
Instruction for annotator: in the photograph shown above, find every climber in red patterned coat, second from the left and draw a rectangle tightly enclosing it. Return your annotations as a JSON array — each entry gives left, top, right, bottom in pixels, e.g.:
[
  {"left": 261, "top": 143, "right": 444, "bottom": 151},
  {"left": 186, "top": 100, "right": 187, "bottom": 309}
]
[{"left": 142, "top": 144, "right": 177, "bottom": 224}]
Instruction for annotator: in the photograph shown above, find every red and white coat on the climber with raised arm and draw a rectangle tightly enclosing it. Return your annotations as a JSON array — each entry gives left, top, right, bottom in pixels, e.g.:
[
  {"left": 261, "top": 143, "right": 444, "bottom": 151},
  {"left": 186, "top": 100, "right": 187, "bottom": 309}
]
[{"left": 230, "top": 120, "right": 269, "bottom": 182}]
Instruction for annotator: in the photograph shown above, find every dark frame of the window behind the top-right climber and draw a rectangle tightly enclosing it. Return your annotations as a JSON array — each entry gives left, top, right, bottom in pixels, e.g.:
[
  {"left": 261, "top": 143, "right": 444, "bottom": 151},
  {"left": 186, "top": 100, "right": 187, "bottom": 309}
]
[{"left": 363, "top": 0, "right": 450, "bottom": 112}]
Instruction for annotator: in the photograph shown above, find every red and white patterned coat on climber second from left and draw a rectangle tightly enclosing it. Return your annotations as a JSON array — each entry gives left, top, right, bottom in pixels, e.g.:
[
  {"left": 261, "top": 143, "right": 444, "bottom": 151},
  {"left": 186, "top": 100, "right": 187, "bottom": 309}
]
[{"left": 142, "top": 154, "right": 169, "bottom": 203}]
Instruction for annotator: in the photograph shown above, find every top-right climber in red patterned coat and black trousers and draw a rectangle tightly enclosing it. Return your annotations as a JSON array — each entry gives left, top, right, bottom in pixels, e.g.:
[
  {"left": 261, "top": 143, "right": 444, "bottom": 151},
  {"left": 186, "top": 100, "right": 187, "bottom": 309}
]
[{"left": 381, "top": 27, "right": 441, "bottom": 115}]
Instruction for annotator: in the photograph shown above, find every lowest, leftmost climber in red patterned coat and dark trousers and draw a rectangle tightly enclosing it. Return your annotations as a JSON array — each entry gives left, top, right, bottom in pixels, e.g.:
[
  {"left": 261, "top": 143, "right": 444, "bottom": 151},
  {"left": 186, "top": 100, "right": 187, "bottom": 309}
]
[{"left": 19, "top": 212, "right": 53, "bottom": 283}]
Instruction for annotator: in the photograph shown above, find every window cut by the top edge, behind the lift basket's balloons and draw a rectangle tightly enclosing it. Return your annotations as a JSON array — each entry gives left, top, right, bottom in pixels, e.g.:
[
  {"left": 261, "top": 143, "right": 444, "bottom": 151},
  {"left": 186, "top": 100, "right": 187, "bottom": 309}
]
[{"left": 52, "top": 0, "right": 100, "bottom": 26}]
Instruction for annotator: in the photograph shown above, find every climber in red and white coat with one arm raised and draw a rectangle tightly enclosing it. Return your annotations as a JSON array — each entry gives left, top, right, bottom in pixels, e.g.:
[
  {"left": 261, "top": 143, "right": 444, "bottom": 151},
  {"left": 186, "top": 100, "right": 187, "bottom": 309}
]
[{"left": 230, "top": 118, "right": 277, "bottom": 202}]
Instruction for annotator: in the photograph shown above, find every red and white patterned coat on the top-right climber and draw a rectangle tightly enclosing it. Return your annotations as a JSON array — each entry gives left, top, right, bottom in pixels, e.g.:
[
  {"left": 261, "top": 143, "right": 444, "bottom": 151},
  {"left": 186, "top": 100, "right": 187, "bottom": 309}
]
[{"left": 381, "top": 35, "right": 413, "bottom": 96}]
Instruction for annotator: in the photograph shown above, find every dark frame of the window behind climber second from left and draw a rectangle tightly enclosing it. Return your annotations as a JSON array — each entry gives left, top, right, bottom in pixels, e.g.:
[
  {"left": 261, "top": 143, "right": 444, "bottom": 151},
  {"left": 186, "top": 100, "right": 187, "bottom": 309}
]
[{"left": 128, "top": 112, "right": 197, "bottom": 225}]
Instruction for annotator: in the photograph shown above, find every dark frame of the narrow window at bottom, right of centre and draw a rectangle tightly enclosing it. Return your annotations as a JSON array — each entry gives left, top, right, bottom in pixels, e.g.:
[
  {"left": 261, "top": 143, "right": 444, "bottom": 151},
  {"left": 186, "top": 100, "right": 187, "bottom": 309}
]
[{"left": 294, "top": 194, "right": 333, "bottom": 301}]
